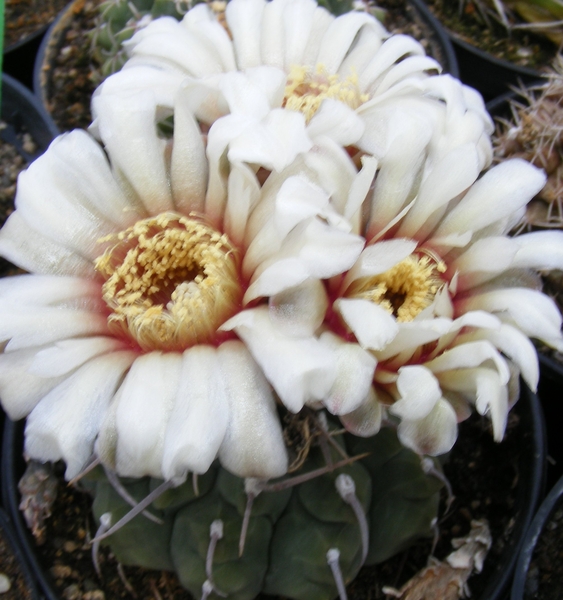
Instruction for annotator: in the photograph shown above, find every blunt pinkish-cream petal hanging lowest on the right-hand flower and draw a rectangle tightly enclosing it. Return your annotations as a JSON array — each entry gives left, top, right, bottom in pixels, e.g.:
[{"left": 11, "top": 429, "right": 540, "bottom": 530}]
[{"left": 397, "top": 399, "right": 457, "bottom": 456}]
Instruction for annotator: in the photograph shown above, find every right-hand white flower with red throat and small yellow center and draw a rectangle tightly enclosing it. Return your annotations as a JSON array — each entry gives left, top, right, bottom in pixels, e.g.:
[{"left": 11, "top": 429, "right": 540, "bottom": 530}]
[{"left": 222, "top": 132, "right": 563, "bottom": 455}]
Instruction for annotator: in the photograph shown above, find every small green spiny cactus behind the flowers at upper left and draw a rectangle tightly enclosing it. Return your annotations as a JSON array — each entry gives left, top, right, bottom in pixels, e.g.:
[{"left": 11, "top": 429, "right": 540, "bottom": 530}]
[{"left": 90, "top": 0, "right": 204, "bottom": 80}]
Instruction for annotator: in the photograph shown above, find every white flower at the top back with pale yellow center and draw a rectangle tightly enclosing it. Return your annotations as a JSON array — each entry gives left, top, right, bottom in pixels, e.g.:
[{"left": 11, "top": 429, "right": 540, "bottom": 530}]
[{"left": 92, "top": 0, "right": 493, "bottom": 168}]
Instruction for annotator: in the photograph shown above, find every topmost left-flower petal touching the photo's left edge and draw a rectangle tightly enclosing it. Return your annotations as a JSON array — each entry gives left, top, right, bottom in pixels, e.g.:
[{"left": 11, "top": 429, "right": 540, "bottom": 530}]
[{"left": 0, "top": 211, "right": 95, "bottom": 277}]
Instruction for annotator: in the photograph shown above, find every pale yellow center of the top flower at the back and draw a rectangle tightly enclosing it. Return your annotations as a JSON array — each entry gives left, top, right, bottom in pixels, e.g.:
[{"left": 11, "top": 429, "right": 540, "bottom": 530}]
[{"left": 282, "top": 65, "right": 369, "bottom": 122}]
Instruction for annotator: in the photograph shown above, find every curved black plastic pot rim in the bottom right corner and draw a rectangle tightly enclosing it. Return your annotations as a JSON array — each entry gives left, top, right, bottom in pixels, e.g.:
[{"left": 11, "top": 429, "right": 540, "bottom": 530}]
[{"left": 510, "top": 477, "right": 563, "bottom": 600}]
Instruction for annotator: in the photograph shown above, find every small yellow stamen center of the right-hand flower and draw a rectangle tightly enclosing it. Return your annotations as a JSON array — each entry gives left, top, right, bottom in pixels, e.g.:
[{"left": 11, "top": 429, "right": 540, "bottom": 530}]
[{"left": 346, "top": 254, "right": 446, "bottom": 322}]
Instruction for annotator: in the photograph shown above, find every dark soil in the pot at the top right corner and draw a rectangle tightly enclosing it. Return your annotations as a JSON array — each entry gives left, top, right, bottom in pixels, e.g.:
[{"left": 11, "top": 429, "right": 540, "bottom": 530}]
[{"left": 427, "top": 0, "right": 557, "bottom": 70}]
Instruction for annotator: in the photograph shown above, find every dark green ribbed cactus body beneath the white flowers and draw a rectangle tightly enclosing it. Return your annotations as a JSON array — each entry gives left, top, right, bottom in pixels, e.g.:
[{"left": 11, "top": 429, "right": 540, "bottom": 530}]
[{"left": 87, "top": 422, "right": 441, "bottom": 600}]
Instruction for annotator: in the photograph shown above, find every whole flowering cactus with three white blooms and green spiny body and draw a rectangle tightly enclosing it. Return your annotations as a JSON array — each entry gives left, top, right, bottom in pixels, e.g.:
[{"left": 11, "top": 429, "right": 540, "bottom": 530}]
[{"left": 0, "top": 0, "right": 563, "bottom": 600}]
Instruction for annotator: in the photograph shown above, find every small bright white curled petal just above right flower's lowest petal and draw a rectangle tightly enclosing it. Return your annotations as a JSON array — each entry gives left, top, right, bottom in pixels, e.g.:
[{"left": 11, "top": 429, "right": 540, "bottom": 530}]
[{"left": 389, "top": 365, "right": 442, "bottom": 421}]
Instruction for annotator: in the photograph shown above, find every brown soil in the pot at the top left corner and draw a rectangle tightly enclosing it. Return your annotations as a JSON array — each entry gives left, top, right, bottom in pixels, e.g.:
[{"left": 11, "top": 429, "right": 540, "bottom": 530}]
[{"left": 4, "top": 0, "right": 67, "bottom": 48}]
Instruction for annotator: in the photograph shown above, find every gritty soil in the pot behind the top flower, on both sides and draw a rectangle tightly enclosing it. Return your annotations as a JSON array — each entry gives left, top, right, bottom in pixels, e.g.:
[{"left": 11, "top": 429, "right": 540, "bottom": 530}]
[{"left": 39, "top": 0, "right": 454, "bottom": 131}]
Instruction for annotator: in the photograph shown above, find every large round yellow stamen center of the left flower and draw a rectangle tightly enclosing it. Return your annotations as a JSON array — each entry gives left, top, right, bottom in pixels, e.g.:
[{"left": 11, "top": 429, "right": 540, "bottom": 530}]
[{"left": 95, "top": 213, "right": 242, "bottom": 351}]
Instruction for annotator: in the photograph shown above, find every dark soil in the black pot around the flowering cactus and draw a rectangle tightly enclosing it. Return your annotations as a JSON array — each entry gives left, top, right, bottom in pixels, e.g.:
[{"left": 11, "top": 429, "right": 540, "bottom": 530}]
[{"left": 22, "top": 404, "right": 525, "bottom": 600}]
